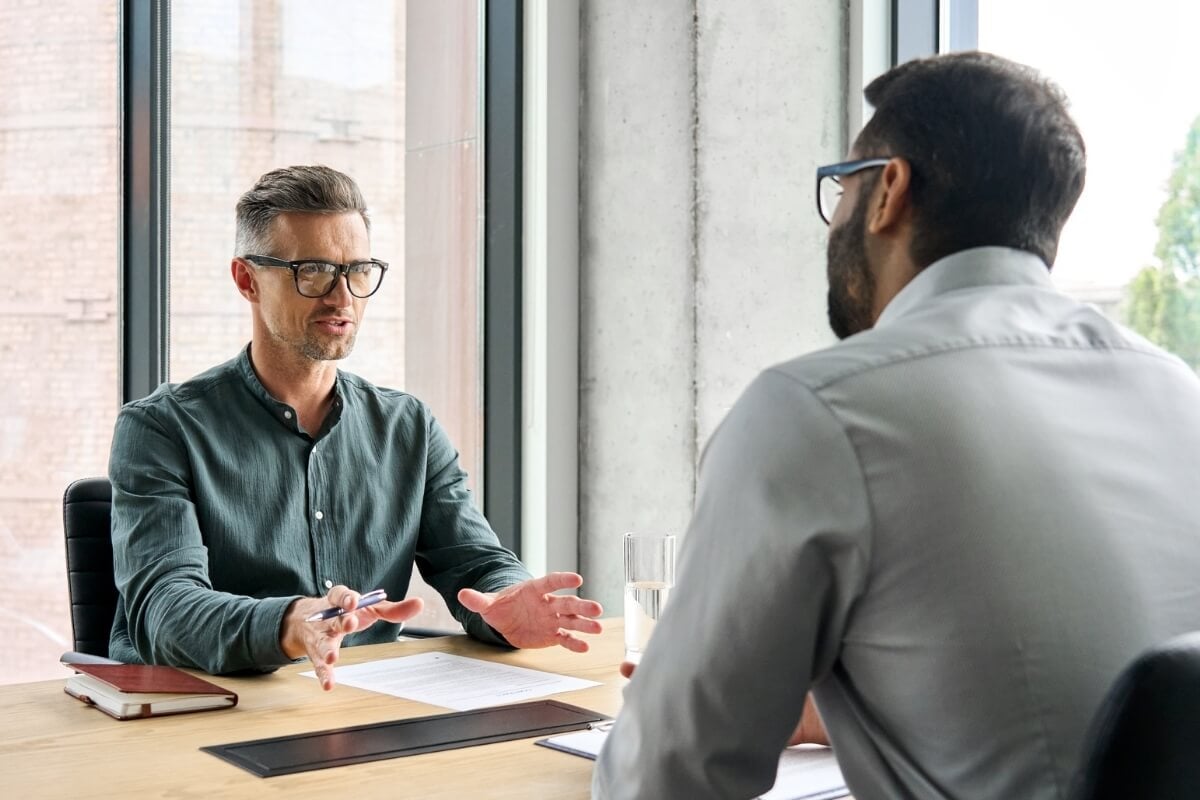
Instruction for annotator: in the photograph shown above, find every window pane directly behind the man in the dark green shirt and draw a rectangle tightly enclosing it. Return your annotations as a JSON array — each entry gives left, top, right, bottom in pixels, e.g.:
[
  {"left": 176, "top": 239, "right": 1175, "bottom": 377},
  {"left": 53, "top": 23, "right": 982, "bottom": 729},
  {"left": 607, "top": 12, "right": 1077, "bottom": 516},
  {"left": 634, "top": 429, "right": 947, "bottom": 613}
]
[{"left": 170, "top": 0, "right": 482, "bottom": 626}]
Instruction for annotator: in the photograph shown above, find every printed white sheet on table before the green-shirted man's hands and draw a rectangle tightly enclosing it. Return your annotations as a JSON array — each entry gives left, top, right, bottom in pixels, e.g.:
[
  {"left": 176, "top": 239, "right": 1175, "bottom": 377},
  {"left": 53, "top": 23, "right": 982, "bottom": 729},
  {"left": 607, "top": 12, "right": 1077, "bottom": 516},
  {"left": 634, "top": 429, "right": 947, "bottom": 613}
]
[{"left": 301, "top": 652, "right": 600, "bottom": 711}]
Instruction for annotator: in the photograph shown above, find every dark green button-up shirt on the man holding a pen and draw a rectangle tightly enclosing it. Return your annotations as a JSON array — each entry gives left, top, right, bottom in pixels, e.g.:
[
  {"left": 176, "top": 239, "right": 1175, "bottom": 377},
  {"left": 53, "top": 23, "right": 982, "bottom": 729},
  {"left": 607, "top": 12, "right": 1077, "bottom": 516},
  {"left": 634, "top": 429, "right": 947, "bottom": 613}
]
[{"left": 108, "top": 348, "right": 529, "bottom": 673}]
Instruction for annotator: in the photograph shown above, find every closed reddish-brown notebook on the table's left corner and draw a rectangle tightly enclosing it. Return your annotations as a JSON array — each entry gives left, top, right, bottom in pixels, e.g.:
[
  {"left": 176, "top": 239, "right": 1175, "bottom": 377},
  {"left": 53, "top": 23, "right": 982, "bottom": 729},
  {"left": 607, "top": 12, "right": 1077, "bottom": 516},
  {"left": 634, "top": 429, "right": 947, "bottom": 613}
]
[{"left": 64, "top": 663, "right": 238, "bottom": 720}]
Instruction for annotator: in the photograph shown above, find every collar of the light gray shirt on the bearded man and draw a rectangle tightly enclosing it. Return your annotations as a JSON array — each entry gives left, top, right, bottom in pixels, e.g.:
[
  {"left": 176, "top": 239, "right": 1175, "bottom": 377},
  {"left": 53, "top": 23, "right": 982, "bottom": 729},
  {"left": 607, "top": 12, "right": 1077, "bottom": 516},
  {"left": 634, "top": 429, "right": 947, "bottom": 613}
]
[{"left": 875, "top": 247, "right": 1054, "bottom": 327}]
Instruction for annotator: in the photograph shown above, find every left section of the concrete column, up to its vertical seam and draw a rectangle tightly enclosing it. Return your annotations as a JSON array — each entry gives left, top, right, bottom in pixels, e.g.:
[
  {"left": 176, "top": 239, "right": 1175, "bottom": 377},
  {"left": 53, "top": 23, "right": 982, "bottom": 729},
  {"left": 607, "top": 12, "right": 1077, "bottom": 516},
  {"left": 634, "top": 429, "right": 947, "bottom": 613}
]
[{"left": 580, "top": 0, "right": 696, "bottom": 606}]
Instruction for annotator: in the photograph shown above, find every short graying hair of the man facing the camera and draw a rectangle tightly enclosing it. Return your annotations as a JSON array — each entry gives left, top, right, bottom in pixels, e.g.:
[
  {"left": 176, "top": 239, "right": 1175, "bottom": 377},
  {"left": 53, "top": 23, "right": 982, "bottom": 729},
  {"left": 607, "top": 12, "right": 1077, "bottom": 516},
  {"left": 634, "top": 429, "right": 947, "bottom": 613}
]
[{"left": 234, "top": 166, "right": 371, "bottom": 255}]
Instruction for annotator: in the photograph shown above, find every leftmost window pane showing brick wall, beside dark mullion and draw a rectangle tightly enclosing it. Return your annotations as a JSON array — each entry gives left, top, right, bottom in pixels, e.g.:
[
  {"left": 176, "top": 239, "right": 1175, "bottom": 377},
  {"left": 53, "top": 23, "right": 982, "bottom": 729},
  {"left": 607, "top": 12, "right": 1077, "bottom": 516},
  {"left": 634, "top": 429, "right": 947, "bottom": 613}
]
[{"left": 0, "top": 0, "right": 120, "bottom": 682}]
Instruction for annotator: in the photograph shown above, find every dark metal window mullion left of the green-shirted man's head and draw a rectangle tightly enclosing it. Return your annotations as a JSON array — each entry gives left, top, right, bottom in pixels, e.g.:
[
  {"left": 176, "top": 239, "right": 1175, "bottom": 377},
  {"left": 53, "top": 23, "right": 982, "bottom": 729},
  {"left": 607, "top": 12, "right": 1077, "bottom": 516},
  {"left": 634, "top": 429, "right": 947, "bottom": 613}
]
[{"left": 120, "top": 0, "right": 170, "bottom": 403}]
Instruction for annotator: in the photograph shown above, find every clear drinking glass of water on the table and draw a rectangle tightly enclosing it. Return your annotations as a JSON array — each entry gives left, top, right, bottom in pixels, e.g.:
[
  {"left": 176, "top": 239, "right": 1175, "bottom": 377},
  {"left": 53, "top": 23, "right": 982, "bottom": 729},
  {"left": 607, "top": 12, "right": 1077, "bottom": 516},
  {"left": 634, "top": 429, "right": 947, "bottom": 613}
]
[{"left": 624, "top": 534, "right": 676, "bottom": 664}]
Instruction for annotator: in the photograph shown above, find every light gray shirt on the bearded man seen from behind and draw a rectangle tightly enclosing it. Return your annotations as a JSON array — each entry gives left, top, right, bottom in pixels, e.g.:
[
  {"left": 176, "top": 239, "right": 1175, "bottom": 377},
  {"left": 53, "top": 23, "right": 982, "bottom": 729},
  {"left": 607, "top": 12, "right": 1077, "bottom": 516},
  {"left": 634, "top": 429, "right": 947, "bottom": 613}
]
[{"left": 593, "top": 248, "right": 1200, "bottom": 800}]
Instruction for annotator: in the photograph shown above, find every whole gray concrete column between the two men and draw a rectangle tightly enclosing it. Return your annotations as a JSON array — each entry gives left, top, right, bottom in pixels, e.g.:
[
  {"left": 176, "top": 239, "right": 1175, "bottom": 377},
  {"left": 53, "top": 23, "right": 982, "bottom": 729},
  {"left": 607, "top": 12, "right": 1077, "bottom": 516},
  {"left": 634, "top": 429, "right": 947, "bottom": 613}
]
[{"left": 580, "top": 0, "right": 858, "bottom": 614}]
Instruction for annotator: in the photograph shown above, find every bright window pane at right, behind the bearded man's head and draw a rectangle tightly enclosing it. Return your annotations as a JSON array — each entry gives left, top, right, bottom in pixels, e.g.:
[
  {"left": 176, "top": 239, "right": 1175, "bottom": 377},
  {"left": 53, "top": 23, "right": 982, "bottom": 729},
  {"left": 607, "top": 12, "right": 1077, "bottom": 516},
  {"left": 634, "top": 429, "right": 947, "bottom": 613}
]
[{"left": 979, "top": 0, "right": 1200, "bottom": 368}]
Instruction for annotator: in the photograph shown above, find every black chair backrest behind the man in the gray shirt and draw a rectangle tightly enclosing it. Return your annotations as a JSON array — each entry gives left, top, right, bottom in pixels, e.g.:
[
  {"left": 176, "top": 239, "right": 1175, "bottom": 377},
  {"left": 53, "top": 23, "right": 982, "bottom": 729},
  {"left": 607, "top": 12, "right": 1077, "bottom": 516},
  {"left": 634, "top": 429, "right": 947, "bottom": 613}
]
[{"left": 1074, "top": 632, "right": 1200, "bottom": 800}]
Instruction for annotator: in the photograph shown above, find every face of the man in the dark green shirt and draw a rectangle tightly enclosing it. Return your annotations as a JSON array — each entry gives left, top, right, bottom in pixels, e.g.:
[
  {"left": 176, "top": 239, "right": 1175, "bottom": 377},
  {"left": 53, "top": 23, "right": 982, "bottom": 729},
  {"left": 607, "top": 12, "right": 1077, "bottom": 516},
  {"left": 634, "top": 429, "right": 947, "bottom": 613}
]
[{"left": 256, "top": 212, "right": 371, "bottom": 361}]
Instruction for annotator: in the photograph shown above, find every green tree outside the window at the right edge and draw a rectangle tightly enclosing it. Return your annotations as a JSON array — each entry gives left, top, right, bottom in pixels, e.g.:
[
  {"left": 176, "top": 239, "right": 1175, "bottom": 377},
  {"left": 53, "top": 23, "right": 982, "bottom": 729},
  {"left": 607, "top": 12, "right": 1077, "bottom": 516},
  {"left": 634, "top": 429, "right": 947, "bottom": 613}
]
[{"left": 1124, "top": 116, "right": 1200, "bottom": 371}]
